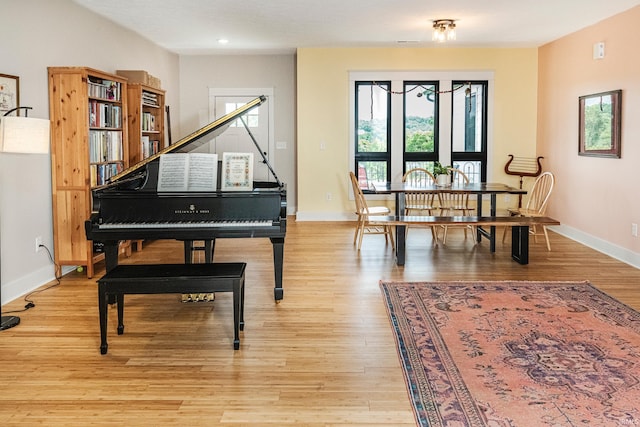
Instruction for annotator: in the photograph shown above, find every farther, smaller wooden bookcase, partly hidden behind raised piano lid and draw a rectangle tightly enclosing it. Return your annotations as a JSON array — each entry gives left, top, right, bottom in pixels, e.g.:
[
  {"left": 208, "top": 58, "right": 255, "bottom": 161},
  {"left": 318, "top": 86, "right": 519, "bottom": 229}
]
[{"left": 127, "top": 83, "right": 166, "bottom": 166}]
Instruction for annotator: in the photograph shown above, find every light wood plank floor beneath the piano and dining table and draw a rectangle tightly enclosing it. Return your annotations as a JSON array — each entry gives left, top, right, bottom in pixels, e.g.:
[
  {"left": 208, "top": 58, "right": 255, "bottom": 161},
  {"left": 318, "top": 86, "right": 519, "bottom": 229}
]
[{"left": 0, "top": 219, "right": 640, "bottom": 426}]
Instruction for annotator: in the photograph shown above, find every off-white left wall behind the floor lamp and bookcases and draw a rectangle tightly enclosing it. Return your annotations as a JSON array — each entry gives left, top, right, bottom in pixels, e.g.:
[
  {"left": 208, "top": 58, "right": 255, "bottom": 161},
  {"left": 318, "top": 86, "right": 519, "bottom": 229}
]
[{"left": 0, "top": 0, "right": 180, "bottom": 303}]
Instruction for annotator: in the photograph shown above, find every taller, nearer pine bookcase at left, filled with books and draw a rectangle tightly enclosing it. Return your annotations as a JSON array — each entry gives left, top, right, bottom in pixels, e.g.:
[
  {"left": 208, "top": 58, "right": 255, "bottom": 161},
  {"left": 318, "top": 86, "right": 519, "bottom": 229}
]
[{"left": 48, "top": 67, "right": 129, "bottom": 277}]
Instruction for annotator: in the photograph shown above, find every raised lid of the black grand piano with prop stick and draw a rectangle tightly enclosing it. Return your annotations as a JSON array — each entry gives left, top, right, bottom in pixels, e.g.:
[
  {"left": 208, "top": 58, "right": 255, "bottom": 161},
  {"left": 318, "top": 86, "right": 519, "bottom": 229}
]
[{"left": 102, "top": 95, "right": 268, "bottom": 191}]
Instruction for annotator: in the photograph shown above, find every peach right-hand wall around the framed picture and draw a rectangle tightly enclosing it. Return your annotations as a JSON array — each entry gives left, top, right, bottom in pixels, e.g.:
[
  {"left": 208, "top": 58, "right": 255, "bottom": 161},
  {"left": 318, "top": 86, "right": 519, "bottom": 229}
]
[{"left": 537, "top": 7, "right": 640, "bottom": 258}]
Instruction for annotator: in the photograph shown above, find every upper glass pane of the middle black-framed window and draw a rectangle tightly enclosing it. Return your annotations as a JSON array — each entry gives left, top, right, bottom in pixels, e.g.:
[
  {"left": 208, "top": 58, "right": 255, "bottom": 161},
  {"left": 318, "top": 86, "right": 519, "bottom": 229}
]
[{"left": 404, "top": 82, "right": 437, "bottom": 153}]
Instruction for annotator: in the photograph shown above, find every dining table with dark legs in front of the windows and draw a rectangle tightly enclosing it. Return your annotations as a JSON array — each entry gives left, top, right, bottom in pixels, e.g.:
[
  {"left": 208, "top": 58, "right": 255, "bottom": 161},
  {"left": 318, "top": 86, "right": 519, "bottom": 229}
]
[{"left": 370, "top": 182, "right": 527, "bottom": 259}]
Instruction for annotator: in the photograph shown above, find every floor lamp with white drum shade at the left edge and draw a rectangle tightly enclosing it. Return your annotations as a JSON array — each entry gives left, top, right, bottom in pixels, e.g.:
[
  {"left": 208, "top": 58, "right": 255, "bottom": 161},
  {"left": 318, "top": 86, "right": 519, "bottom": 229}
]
[{"left": 0, "top": 107, "right": 49, "bottom": 331}]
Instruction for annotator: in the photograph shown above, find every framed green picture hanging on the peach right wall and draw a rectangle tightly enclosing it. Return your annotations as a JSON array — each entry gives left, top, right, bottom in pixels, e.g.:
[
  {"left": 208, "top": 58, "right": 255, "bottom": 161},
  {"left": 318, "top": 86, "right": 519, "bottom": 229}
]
[{"left": 578, "top": 90, "right": 622, "bottom": 159}]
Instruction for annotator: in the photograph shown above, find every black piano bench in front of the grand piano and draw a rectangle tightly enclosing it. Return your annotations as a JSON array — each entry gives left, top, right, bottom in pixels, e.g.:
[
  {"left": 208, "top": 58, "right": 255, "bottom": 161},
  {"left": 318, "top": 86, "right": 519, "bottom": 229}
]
[{"left": 98, "top": 262, "right": 247, "bottom": 354}]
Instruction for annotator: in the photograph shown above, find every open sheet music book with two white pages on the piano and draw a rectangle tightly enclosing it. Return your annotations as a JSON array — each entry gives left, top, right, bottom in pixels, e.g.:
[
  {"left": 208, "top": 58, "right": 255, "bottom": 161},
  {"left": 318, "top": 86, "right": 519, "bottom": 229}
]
[{"left": 158, "top": 153, "right": 218, "bottom": 192}]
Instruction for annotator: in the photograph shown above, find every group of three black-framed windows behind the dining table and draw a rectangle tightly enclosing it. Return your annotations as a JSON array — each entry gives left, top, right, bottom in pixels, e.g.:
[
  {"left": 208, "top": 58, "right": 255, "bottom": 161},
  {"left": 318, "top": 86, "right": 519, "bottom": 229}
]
[{"left": 352, "top": 73, "right": 490, "bottom": 189}]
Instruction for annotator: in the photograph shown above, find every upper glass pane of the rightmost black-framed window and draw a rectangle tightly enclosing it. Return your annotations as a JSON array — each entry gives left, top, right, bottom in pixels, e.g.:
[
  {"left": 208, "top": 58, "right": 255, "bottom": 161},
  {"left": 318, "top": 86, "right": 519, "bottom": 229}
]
[{"left": 452, "top": 83, "right": 485, "bottom": 153}]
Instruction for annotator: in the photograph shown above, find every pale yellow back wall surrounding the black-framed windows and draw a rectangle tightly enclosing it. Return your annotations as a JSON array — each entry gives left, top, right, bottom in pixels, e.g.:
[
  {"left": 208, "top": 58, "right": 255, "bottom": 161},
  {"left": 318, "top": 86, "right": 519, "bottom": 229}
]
[{"left": 297, "top": 48, "right": 538, "bottom": 220}]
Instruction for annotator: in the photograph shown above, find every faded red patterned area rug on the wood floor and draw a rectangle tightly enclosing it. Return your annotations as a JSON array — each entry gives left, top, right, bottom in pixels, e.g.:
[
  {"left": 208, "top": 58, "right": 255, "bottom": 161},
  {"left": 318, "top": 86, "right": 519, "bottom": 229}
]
[{"left": 380, "top": 282, "right": 640, "bottom": 427}]
